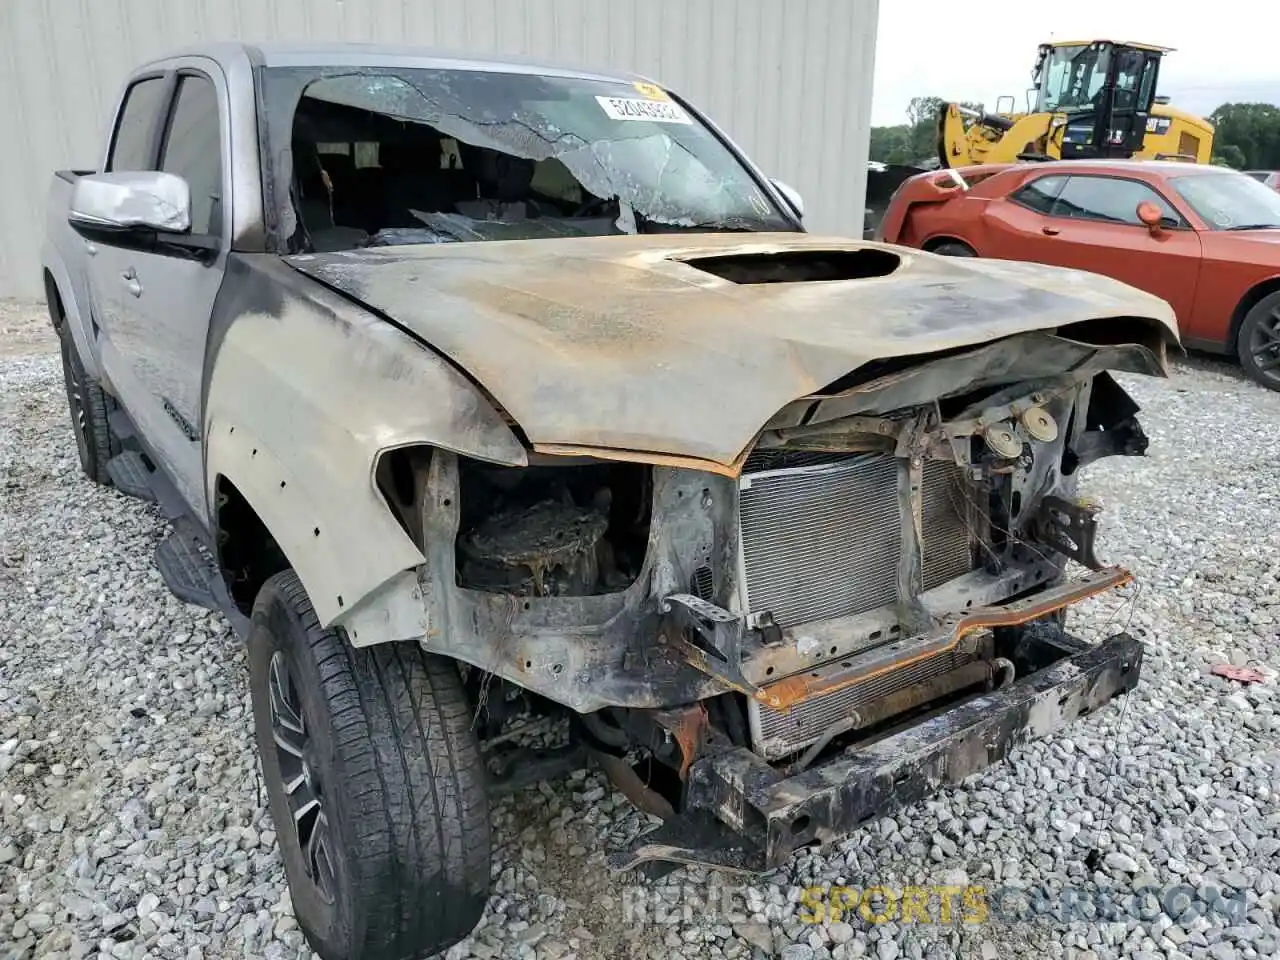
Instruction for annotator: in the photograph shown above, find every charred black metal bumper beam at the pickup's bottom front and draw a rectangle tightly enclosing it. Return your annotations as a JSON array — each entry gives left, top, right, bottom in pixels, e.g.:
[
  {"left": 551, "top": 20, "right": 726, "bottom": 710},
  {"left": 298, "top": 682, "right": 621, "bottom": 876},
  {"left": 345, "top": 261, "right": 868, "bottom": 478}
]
[{"left": 611, "top": 634, "right": 1143, "bottom": 872}]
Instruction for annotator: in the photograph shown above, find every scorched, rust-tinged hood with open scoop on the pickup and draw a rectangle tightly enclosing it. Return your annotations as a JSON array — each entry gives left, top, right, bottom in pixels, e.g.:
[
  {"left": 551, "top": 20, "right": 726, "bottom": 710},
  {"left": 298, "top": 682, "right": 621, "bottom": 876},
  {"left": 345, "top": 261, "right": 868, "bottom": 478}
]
[{"left": 288, "top": 233, "right": 1176, "bottom": 465}]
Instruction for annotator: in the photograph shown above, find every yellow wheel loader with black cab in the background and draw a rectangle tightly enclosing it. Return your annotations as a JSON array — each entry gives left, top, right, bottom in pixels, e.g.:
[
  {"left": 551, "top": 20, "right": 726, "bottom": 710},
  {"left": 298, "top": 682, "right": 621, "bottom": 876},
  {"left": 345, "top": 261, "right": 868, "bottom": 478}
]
[{"left": 938, "top": 40, "right": 1213, "bottom": 166}]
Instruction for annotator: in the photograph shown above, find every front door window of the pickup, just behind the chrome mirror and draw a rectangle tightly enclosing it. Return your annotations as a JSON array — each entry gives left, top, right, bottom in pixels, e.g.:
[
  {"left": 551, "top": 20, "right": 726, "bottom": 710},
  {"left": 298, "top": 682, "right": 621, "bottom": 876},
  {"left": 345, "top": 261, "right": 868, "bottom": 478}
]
[{"left": 160, "top": 74, "right": 223, "bottom": 237}]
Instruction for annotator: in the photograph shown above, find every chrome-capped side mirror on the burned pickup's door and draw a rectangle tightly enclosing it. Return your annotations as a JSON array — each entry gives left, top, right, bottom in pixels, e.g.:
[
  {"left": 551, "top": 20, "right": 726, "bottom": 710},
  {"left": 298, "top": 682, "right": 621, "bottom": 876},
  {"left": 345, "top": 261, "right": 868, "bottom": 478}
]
[{"left": 67, "top": 170, "right": 191, "bottom": 237}]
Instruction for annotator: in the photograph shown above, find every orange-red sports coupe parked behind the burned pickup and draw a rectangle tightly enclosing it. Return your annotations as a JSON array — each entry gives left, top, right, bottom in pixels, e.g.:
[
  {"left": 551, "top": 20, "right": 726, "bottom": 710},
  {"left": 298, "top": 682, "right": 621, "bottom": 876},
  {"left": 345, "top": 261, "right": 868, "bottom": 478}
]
[{"left": 878, "top": 160, "right": 1280, "bottom": 390}]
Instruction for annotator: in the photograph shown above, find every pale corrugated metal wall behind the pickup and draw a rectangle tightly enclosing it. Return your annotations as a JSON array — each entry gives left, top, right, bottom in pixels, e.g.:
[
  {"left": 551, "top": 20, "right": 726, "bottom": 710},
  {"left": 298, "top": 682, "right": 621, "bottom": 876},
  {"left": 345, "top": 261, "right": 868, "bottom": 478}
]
[{"left": 0, "top": 0, "right": 878, "bottom": 296}]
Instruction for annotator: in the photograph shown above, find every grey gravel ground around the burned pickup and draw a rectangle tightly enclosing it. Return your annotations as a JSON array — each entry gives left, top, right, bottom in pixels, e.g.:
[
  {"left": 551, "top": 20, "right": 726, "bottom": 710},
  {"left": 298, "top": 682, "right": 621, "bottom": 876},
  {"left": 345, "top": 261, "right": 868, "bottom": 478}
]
[{"left": 0, "top": 305, "right": 1280, "bottom": 960}]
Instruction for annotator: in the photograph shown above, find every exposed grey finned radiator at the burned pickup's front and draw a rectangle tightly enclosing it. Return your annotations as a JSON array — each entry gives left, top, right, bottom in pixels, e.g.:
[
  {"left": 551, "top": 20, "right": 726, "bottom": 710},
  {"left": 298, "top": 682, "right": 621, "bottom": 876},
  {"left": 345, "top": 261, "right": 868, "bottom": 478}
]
[{"left": 739, "top": 451, "right": 986, "bottom": 758}]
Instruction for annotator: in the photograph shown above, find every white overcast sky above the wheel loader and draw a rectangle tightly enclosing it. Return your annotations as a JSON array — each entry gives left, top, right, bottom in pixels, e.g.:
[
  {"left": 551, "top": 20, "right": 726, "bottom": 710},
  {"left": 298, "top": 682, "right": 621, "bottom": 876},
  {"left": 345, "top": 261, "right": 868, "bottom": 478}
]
[{"left": 872, "top": 0, "right": 1280, "bottom": 125}]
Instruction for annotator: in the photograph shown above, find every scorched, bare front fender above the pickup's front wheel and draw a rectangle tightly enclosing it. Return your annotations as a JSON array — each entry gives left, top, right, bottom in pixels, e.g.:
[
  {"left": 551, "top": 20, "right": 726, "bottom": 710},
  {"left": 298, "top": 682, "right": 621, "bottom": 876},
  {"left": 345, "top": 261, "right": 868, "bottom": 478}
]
[{"left": 204, "top": 255, "right": 527, "bottom": 625}]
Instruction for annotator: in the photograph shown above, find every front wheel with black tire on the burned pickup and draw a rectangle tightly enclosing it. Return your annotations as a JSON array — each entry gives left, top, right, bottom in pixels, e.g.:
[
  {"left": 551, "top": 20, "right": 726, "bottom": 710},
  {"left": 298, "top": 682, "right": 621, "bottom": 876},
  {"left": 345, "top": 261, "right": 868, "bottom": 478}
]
[{"left": 248, "top": 571, "right": 490, "bottom": 960}]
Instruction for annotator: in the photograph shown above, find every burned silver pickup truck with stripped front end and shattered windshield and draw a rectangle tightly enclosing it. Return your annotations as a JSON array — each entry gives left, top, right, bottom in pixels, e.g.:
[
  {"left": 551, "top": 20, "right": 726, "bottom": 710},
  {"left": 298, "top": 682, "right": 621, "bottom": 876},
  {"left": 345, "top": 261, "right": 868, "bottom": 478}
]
[{"left": 45, "top": 45, "right": 1176, "bottom": 960}]
